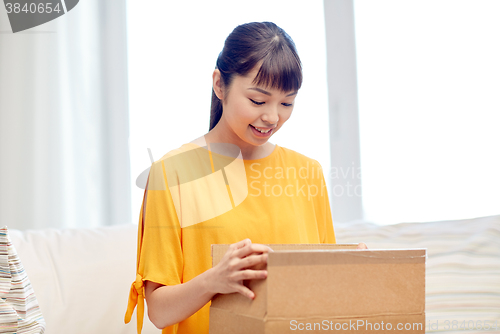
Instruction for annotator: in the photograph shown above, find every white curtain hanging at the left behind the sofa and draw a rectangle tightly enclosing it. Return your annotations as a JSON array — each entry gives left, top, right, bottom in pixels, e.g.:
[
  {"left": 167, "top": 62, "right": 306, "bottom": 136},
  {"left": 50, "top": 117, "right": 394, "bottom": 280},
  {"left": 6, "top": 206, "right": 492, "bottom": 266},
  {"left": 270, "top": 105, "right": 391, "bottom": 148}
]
[{"left": 0, "top": 0, "right": 131, "bottom": 229}]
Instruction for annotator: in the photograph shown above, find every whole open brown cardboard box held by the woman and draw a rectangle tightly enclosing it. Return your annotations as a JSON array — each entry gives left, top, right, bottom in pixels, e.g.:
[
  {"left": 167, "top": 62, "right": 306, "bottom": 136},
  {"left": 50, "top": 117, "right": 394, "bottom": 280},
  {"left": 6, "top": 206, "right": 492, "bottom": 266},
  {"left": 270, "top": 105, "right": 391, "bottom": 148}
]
[{"left": 210, "top": 244, "right": 426, "bottom": 334}]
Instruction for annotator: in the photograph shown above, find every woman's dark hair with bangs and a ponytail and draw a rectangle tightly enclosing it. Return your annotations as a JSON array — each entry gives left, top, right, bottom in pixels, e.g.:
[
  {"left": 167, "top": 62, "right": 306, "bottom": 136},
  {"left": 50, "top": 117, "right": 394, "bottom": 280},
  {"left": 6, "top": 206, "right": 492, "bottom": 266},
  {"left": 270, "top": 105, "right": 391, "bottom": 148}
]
[{"left": 209, "top": 22, "right": 302, "bottom": 131}]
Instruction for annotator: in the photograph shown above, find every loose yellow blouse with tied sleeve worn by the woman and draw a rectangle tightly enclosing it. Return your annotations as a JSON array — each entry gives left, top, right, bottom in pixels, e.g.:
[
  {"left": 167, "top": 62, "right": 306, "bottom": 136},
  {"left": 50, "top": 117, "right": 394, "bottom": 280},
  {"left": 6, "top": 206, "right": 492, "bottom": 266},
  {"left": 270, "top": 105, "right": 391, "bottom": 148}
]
[{"left": 125, "top": 143, "right": 335, "bottom": 334}]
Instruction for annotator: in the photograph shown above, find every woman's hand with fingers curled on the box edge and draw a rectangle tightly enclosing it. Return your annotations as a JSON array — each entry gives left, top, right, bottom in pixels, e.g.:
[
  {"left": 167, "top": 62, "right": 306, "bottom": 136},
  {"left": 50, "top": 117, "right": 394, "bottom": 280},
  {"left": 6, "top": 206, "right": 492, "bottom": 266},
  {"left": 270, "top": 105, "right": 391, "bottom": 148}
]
[{"left": 208, "top": 239, "right": 273, "bottom": 299}]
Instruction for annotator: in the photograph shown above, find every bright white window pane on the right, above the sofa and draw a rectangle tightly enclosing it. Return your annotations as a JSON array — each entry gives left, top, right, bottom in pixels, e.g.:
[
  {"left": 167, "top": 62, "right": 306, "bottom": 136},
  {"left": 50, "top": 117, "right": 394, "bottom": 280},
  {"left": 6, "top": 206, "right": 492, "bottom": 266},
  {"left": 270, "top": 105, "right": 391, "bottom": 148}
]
[{"left": 355, "top": 0, "right": 500, "bottom": 224}]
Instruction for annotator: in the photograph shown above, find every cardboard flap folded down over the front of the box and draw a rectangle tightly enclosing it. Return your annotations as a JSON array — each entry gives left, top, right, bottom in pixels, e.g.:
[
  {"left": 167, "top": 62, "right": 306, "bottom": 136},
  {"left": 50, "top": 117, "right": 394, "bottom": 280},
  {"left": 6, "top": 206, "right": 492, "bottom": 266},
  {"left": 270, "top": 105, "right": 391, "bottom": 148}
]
[{"left": 266, "top": 249, "right": 426, "bottom": 318}]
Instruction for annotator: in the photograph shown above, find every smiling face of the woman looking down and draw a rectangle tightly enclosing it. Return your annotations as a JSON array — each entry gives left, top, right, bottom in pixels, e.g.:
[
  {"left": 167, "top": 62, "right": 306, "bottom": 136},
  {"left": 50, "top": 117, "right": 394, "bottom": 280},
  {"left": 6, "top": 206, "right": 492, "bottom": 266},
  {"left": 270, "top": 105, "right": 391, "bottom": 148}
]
[{"left": 214, "top": 67, "right": 297, "bottom": 146}]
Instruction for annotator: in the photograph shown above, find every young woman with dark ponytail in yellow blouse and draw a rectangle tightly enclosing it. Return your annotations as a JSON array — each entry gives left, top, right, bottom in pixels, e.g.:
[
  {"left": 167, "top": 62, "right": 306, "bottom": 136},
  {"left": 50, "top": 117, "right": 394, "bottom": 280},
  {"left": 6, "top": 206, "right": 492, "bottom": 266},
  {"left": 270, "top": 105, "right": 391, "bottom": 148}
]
[{"left": 125, "top": 22, "right": 362, "bottom": 334}]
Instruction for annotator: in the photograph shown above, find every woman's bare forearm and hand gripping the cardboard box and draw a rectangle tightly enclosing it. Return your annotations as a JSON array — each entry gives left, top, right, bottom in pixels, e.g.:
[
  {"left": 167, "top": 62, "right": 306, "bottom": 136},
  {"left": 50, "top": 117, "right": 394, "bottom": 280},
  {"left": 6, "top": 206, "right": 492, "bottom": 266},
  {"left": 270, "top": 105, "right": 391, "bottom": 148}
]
[{"left": 145, "top": 239, "right": 272, "bottom": 329}]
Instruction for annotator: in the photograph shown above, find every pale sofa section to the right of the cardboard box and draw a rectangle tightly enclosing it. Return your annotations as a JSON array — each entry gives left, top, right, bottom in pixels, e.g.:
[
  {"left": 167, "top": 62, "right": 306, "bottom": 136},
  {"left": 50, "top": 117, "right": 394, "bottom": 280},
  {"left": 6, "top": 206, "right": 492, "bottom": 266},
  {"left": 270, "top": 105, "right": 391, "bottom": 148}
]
[{"left": 335, "top": 216, "right": 500, "bottom": 333}]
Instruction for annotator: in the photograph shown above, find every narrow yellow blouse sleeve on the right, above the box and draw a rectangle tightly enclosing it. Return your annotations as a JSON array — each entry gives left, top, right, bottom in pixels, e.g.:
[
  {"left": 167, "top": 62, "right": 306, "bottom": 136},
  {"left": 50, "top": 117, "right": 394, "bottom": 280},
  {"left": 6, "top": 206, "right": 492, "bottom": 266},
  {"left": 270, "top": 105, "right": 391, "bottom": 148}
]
[{"left": 314, "top": 160, "right": 336, "bottom": 244}]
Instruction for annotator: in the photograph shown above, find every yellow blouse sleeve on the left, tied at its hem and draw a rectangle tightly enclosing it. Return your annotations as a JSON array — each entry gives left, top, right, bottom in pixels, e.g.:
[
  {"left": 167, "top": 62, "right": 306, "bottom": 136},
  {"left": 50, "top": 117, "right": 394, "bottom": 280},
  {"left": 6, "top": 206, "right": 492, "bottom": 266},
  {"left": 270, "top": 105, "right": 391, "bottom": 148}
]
[{"left": 125, "top": 160, "right": 183, "bottom": 334}]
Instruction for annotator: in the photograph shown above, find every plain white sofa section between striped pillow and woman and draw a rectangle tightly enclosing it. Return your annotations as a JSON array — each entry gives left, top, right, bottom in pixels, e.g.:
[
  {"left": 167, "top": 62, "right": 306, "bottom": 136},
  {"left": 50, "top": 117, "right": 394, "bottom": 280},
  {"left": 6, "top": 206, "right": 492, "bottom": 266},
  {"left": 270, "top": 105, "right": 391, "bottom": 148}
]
[{"left": 9, "top": 224, "right": 160, "bottom": 334}]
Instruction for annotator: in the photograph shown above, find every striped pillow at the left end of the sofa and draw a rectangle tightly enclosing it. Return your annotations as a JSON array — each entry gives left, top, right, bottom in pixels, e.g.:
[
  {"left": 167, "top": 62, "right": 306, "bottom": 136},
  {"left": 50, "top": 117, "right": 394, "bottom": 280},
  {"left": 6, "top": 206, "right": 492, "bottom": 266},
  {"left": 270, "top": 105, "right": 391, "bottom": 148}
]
[{"left": 0, "top": 227, "right": 45, "bottom": 334}]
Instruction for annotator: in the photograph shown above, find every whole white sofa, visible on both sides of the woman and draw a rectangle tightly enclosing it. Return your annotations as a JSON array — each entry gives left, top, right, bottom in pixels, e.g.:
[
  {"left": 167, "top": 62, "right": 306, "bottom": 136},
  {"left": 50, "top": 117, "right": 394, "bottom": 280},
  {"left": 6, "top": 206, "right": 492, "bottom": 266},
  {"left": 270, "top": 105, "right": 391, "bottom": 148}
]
[{"left": 9, "top": 216, "right": 500, "bottom": 334}]
